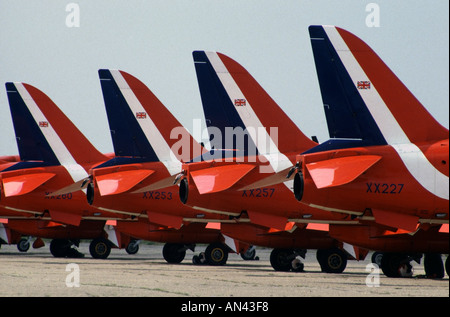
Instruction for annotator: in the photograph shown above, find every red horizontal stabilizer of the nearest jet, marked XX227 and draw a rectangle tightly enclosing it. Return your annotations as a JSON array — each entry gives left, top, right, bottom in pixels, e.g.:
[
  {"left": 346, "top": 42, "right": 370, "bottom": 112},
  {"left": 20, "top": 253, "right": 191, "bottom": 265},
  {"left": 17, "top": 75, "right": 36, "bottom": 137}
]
[{"left": 306, "top": 155, "right": 381, "bottom": 188}]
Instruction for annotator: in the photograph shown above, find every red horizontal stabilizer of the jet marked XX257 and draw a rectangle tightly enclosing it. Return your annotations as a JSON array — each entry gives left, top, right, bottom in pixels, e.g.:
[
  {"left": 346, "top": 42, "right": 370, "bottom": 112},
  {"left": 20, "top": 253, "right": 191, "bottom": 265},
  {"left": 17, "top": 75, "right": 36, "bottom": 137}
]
[{"left": 191, "top": 164, "right": 255, "bottom": 194}]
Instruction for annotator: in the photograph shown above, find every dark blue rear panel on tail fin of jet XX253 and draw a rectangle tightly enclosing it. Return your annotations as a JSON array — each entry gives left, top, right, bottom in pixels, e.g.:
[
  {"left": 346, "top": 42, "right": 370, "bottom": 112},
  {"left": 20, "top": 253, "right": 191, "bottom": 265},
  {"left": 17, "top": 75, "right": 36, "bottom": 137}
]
[{"left": 98, "top": 69, "right": 159, "bottom": 162}]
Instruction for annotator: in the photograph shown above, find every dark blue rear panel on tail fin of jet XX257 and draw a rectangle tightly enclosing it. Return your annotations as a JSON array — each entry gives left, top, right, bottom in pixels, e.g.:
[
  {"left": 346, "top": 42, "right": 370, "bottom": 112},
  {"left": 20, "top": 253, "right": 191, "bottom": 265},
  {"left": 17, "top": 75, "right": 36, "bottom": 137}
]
[{"left": 192, "top": 51, "right": 258, "bottom": 154}]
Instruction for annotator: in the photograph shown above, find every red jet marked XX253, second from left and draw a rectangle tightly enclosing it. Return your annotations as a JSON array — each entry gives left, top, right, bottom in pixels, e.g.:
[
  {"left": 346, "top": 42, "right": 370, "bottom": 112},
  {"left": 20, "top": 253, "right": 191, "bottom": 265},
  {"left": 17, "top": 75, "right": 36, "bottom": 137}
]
[{"left": 64, "top": 69, "right": 256, "bottom": 265}]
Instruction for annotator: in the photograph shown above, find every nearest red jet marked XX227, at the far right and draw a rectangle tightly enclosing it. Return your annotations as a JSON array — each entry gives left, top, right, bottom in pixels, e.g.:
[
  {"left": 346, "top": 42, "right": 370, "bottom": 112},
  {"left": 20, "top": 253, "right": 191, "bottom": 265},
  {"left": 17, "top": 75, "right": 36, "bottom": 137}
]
[{"left": 294, "top": 26, "right": 449, "bottom": 277}]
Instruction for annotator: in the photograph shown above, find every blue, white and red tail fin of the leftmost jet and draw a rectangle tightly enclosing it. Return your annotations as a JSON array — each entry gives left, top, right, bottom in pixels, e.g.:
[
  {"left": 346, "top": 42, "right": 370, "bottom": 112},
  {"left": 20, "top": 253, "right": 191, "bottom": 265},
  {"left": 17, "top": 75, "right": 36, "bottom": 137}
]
[{"left": 6, "top": 82, "right": 107, "bottom": 165}]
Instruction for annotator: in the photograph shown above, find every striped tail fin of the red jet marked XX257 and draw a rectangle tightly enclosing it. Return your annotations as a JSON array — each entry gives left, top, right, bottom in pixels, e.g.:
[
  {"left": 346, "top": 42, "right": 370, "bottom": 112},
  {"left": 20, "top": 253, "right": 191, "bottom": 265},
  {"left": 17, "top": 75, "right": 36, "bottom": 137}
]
[{"left": 193, "top": 51, "right": 316, "bottom": 154}]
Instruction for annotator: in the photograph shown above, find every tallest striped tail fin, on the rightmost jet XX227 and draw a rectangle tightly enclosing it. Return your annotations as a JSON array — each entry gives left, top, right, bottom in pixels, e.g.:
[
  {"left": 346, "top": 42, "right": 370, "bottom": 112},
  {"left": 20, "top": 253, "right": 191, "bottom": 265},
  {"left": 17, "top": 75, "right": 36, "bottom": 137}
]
[{"left": 309, "top": 26, "right": 448, "bottom": 145}]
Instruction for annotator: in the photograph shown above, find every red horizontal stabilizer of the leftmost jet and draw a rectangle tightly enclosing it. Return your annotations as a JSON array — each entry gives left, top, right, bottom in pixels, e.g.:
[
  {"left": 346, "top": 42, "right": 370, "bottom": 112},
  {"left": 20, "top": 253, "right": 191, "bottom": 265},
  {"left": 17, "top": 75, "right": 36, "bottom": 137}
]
[{"left": 3, "top": 173, "right": 55, "bottom": 197}]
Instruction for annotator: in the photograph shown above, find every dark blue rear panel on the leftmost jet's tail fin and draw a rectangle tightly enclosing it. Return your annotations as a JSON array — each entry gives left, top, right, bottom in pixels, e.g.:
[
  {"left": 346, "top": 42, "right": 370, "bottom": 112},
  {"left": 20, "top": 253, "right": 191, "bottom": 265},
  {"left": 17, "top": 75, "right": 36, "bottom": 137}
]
[{"left": 5, "top": 83, "right": 60, "bottom": 165}]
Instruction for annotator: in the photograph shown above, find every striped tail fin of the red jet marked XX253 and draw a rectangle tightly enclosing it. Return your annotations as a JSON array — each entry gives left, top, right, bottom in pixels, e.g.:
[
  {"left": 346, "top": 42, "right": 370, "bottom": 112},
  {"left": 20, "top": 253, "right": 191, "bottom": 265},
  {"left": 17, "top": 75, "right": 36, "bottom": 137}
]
[{"left": 99, "top": 69, "right": 203, "bottom": 169}]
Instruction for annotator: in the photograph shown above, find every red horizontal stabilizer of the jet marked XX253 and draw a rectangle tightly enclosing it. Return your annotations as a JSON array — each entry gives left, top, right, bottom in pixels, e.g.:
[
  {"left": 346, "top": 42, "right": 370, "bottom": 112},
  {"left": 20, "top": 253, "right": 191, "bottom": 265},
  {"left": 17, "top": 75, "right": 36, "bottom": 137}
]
[{"left": 95, "top": 169, "right": 155, "bottom": 196}]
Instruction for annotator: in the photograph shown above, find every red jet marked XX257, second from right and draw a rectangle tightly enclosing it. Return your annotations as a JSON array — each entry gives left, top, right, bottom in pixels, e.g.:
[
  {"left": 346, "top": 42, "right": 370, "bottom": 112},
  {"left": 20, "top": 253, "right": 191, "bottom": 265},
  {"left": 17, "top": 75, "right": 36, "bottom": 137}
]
[{"left": 175, "top": 51, "right": 366, "bottom": 272}]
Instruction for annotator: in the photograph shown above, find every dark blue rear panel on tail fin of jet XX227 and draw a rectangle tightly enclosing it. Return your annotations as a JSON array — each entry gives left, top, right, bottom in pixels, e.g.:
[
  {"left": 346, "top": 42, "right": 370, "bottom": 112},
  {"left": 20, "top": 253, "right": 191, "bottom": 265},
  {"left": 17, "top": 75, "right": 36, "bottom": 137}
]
[{"left": 309, "top": 26, "right": 387, "bottom": 145}]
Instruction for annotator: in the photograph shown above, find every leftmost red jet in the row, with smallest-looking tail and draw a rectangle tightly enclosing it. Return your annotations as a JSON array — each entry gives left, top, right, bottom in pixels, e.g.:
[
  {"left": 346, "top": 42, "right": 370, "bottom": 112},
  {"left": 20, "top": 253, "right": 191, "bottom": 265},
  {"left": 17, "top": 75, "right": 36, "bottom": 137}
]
[{"left": 0, "top": 83, "right": 137, "bottom": 257}]
